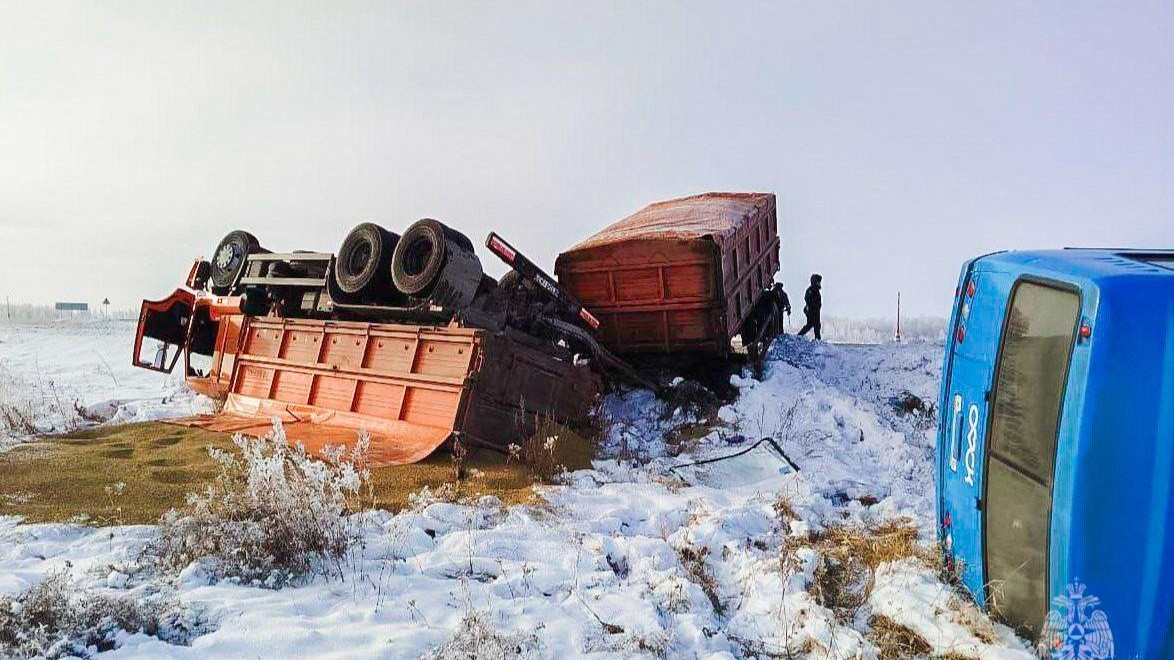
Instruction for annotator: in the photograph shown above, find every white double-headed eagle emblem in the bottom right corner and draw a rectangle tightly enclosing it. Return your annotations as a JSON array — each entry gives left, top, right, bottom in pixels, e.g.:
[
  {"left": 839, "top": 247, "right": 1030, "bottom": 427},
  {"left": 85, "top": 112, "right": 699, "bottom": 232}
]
[{"left": 1039, "top": 580, "right": 1115, "bottom": 660}]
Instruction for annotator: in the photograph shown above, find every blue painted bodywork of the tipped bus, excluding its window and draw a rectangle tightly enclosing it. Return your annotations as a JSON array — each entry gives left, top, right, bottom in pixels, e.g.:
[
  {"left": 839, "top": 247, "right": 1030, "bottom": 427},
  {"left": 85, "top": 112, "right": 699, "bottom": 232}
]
[{"left": 937, "top": 249, "right": 1174, "bottom": 659}]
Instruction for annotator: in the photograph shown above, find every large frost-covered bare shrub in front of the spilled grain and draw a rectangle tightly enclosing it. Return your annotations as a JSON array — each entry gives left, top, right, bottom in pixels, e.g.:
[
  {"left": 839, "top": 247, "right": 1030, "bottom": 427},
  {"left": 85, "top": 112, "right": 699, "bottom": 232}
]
[{"left": 144, "top": 420, "right": 369, "bottom": 588}]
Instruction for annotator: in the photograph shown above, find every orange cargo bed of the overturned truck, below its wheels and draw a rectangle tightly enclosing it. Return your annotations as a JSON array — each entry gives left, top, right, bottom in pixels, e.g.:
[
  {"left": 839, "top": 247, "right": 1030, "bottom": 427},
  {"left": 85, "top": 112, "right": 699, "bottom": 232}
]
[{"left": 167, "top": 311, "right": 599, "bottom": 466}]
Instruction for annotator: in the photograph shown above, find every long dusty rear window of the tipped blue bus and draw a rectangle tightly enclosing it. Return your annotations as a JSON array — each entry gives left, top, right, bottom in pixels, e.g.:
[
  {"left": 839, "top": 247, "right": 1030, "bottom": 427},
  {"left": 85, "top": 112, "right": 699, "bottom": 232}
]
[{"left": 985, "top": 281, "right": 1080, "bottom": 635}]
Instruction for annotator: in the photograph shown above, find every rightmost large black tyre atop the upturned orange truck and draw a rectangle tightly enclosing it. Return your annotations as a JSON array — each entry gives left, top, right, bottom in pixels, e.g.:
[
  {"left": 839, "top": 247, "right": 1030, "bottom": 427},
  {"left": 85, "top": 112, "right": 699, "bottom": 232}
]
[{"left": 391, "top": 218, "right": 484, "bottom": 310}]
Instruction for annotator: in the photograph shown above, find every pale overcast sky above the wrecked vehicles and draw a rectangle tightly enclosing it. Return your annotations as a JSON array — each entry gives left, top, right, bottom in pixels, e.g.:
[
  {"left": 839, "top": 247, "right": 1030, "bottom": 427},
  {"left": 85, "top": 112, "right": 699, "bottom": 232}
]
[{"left": 0, "top": 0, "right": 1174, "bottom": 316}]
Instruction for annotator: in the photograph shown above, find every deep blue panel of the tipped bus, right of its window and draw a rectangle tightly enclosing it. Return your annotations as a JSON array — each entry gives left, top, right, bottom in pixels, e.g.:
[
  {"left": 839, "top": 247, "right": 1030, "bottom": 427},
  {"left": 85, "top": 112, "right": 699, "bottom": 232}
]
[{"left": 1051, "top": 274, "right": 1174, "bottom": 658}]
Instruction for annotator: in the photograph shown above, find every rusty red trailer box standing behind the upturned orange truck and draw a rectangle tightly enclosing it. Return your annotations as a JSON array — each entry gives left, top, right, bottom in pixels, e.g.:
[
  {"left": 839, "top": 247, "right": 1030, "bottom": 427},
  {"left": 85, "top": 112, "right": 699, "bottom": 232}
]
[{"left": 555, "top": 193, "right": 780, "bottom": 355}]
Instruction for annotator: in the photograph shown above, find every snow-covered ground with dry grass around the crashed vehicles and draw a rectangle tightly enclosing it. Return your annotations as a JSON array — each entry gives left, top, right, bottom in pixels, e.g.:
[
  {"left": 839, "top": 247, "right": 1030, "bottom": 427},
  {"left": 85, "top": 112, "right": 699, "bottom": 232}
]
[{"left": 0, "top": 323, "right": 1034, "bottom": 660}]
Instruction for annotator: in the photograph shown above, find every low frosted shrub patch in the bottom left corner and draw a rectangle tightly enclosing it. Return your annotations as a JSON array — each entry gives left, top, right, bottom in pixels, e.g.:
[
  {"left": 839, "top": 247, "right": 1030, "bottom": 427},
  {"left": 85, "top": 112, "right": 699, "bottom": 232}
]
[{"left": 0, "top": 571, "right": 203, "bottom": 659}]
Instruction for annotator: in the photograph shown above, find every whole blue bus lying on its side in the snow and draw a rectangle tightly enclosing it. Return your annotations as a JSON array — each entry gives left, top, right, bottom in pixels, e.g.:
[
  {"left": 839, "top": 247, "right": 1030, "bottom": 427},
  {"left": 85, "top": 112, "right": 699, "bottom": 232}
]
[{"left": 937, "top": 249, "right": 1174, "bottom": 659}]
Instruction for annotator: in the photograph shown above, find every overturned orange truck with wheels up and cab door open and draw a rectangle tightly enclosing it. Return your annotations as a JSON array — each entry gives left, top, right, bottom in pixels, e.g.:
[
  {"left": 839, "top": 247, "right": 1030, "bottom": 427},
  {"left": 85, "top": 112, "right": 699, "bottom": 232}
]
[{"left": 134, "top": 196, "right": 777, "bottom": 465}]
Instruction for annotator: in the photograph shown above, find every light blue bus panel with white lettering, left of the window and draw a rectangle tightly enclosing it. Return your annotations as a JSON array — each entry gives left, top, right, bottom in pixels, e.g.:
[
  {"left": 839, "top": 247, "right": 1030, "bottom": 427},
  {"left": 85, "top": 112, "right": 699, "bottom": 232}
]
[{"left": 937, "top": 260, "right": 1011, "bottom": 600}]
